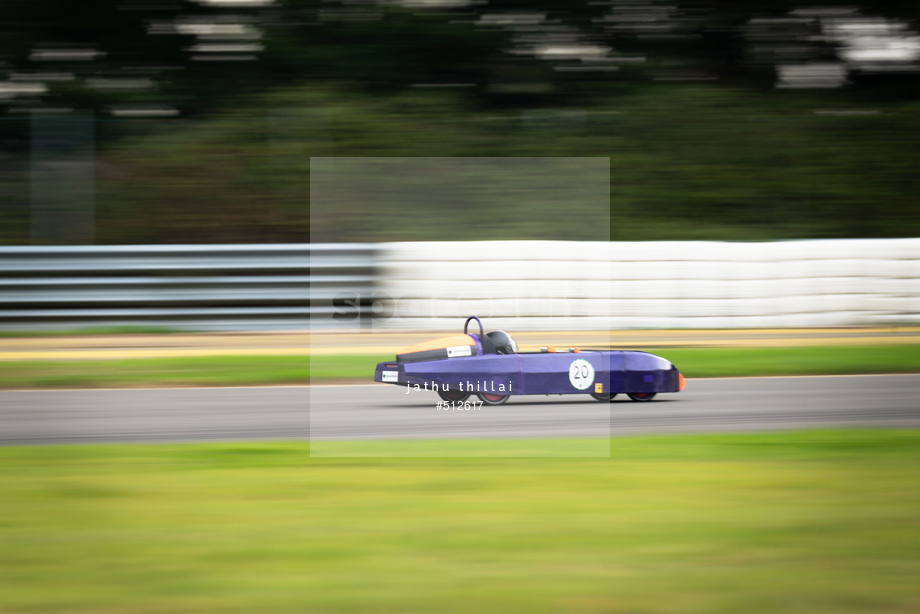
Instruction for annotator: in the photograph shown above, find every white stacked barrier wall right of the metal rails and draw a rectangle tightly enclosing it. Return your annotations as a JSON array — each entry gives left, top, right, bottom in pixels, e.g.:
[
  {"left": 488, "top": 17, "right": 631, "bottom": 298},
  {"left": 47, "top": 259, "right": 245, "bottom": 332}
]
[{"left": 375, "top": 239, "right": 920, "bottom": 331}]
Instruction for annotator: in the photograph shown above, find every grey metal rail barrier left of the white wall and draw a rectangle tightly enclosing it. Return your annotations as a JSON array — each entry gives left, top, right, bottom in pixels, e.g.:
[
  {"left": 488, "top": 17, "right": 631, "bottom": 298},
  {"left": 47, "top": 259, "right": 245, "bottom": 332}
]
[{"left": 0, "top": 244, "right": 379, "bottom": 330}]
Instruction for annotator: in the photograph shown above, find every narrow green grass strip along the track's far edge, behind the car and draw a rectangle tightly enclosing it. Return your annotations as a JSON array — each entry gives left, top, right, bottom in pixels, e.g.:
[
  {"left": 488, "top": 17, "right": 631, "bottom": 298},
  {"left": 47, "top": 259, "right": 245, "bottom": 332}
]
[{"left": 0, "top": 344, "right": 920, "bottom": 389}]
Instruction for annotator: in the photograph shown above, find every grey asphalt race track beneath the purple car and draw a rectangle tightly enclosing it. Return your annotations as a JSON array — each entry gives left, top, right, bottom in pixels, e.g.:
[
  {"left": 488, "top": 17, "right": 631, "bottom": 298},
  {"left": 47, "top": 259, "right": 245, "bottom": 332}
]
[{"left": 0, "top": 375, "right": 920, "bottom": 445}]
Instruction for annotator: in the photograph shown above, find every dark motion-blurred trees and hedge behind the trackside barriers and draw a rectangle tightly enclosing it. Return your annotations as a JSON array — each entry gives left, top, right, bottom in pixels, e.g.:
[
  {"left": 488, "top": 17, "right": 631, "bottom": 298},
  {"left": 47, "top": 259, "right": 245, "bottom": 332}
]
[{"left": 0, "top": 0, "right": 920, "bottom": 244}]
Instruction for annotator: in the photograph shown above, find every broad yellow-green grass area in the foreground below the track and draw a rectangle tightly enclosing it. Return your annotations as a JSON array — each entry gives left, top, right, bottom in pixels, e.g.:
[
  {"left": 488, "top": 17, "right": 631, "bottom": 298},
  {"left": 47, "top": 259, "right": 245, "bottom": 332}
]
[{"left": 0, "top": 430, "right": 920, "bottom": 614}]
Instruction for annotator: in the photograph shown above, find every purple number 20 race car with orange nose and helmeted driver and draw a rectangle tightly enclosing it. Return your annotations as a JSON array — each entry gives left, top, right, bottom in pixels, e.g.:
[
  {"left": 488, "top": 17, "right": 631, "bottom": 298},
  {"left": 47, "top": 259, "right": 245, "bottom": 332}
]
[{"left": 374, "top": 316, "right": 684, "bottom": 405}]
